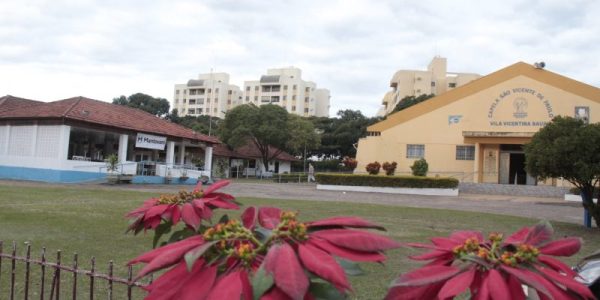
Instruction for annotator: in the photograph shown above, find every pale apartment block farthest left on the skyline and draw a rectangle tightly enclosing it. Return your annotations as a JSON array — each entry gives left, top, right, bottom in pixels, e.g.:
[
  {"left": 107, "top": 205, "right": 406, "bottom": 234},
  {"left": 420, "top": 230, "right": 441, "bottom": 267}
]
[{"left": 172, "top": 73, "right": 242, "bottom": 118}]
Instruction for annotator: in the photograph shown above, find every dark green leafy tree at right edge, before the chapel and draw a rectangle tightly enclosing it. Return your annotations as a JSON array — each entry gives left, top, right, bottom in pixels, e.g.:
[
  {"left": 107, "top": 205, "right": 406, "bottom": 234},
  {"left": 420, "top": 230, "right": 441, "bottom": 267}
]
[{"left": 524, "top": 116, "right": 600, "bottom": 228}]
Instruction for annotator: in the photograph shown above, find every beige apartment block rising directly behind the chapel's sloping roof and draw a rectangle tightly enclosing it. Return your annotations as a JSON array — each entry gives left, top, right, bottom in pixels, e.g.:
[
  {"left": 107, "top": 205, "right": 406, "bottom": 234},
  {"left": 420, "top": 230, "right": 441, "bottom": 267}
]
[{"left": 377, "top": 56, "right": 481, "bottom": 116}]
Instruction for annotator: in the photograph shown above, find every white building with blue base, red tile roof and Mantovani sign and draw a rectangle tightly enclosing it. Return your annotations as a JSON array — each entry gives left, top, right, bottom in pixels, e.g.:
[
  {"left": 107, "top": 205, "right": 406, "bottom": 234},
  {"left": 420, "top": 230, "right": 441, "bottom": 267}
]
[{"left": 0, "top": 96, "right": 220, "bottom": 183}]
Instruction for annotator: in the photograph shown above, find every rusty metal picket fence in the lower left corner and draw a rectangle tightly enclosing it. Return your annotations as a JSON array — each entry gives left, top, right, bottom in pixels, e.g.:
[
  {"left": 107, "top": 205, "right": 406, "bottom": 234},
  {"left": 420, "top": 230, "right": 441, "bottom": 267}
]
[{"left": 0, "top": 241, "right": 146, "bottom": 300}]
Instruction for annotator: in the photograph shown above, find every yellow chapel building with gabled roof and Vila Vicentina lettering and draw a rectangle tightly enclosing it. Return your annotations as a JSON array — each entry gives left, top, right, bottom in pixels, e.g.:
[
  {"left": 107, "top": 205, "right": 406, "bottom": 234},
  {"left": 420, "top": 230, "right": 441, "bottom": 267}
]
[{"left": 356, "top": 62, "right": 600, "bottom": 185}]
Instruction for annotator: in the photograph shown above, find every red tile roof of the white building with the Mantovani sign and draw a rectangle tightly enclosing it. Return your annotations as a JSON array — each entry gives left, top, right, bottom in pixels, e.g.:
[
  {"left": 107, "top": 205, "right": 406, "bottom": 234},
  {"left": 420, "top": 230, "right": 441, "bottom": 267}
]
[{"left": 0, "top": 96, "right": 220, "bottom": 144}]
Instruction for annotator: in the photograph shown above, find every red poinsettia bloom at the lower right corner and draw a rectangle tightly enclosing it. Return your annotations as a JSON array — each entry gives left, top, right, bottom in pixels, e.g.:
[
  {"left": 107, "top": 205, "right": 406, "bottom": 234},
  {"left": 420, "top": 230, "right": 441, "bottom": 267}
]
[{"left": 386, "top": 222, "right": 595, "bottom": 300}]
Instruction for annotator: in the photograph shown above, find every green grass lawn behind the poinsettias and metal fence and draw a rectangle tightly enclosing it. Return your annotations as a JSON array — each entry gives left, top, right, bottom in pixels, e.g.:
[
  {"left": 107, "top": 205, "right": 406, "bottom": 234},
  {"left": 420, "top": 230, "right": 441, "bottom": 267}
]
[{"left": 0, "top": 186, "right": 600, "bottom": 299}]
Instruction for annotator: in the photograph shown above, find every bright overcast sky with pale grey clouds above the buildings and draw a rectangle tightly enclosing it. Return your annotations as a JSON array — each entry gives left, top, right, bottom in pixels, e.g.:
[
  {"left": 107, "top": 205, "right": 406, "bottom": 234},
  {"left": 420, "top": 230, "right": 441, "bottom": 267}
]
[{"left": 0, "top": 0, "right": 600, "bottom": 116}]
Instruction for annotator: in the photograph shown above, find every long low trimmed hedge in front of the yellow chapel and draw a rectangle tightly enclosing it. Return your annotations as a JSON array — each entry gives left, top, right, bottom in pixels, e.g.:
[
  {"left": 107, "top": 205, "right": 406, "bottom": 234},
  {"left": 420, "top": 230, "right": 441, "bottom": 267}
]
[{"left": 315, "top": 173, "right": 458, "bottom": 189}]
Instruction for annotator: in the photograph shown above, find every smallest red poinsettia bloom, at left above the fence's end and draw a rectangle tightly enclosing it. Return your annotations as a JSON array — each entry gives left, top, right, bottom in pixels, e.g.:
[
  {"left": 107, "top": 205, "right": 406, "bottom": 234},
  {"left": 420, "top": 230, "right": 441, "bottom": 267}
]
[{"left": 126, "top": 180, "right": 239, "bottom": 233}]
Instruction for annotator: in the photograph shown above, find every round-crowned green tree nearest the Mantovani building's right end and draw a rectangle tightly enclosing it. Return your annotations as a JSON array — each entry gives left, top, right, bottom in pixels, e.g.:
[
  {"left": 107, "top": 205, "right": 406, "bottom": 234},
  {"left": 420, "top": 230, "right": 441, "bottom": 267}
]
[{"left": 219, "top": 104, "right": 291, "bottom": 170}]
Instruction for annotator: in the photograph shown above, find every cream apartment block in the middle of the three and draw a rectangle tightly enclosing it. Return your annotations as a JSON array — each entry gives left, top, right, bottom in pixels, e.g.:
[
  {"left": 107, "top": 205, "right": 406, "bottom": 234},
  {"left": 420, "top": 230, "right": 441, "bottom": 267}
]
[{"left": 242, "top": 67, "right": 330, "bottom": 117}]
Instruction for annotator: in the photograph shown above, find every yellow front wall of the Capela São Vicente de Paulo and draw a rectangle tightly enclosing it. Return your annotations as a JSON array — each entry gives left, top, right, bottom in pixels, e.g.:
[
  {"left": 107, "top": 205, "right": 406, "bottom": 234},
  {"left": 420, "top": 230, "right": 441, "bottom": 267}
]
[{"left": 356, "top": 70, "right": 600, "bottom": 182}]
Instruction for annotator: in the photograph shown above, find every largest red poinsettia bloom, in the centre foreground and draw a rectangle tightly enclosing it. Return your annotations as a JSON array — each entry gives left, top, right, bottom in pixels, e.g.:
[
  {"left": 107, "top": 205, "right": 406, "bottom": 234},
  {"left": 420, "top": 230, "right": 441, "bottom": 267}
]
[{"left": 129, "top": 207, "right": 399, "bottom": 300}]
